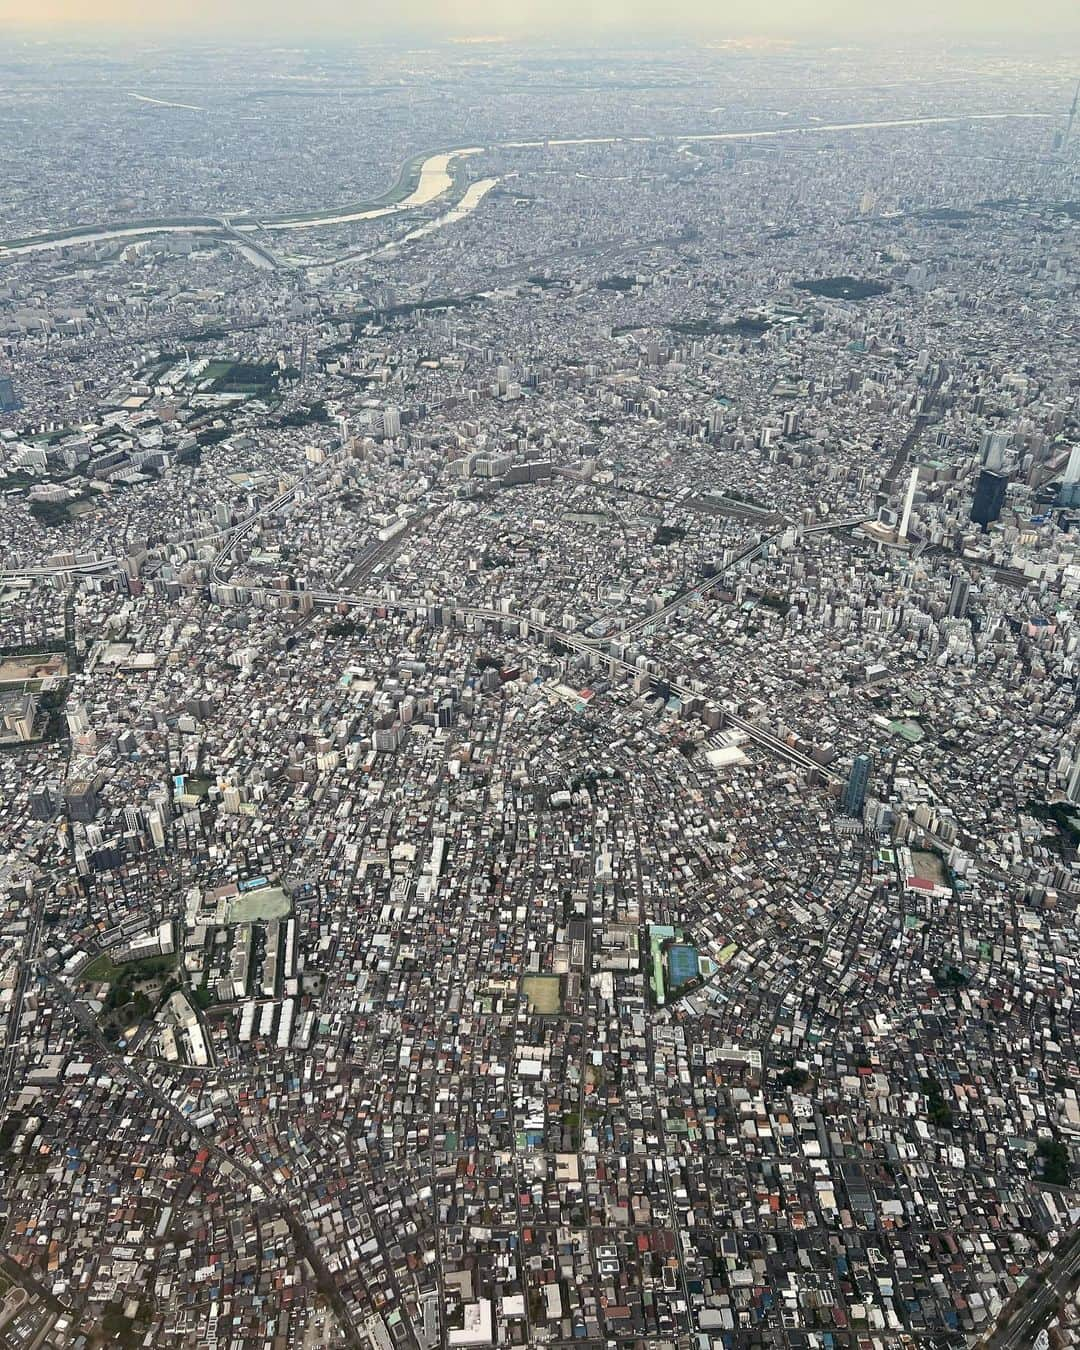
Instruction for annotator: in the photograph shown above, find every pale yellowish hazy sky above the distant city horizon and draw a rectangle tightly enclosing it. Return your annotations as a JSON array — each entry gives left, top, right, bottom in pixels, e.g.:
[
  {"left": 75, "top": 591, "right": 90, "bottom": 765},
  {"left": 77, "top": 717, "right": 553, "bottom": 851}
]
[{"left": 0, "top": 0, "right": 1080, "bottom": 38}]
